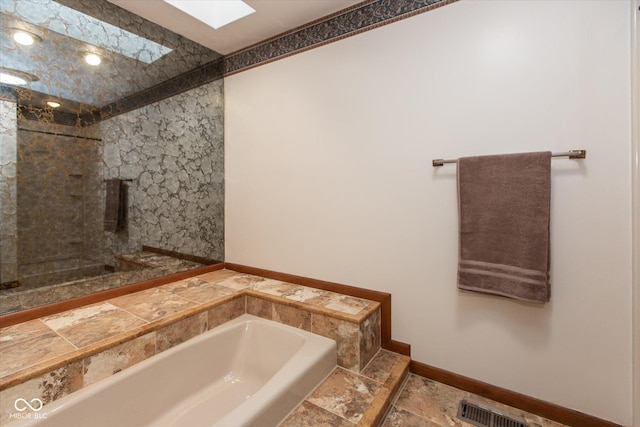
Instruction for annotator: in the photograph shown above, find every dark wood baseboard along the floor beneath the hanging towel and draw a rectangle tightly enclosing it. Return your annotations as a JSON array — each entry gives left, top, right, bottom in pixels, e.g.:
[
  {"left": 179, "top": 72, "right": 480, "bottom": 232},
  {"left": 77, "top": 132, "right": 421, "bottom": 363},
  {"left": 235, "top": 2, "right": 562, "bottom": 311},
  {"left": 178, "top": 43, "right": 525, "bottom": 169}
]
[{"left": 409, "top": 360, "right": 622, "bottom": 427}]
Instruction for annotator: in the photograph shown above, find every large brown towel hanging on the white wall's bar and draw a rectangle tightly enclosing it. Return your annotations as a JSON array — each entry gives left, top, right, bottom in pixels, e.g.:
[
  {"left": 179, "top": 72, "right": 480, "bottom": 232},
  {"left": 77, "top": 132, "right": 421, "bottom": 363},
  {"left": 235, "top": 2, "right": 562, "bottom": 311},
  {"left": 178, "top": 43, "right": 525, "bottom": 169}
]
[{"left": 457, "top": 152, "right": 551, "bottom": 303}]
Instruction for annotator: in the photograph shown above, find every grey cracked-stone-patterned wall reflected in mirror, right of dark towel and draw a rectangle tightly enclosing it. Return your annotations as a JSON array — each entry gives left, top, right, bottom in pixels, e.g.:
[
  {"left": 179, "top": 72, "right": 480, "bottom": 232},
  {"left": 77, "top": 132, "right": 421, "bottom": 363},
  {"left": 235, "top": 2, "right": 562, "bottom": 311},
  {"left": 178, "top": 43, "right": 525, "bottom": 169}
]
[{"left": 94, "top": 79, "right": 224, "bottom": 265}]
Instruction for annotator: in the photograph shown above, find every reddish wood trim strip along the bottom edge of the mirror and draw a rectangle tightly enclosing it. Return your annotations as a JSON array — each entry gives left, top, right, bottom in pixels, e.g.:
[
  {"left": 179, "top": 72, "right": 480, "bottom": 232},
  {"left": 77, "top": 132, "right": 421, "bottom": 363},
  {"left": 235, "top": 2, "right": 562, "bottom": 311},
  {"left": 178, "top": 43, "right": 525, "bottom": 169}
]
[{"left": 0, "top": 263, "right": 224, "bottom": 328}]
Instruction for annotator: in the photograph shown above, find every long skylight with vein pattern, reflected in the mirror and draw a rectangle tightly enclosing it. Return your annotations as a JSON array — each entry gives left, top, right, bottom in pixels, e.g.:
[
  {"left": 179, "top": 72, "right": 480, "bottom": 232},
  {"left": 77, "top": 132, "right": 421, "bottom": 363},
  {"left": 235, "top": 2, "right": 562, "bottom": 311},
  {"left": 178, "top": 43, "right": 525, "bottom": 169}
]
[{"left": 0, "top": 0, "right": 172, "bottom": 64}]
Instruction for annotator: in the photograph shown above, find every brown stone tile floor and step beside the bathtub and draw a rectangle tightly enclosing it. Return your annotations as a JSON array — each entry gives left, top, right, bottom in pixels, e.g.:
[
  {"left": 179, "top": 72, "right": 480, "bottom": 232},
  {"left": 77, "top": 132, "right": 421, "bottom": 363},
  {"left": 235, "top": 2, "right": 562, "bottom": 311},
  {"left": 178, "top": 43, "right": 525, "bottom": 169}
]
[{"left": 279, "top": 350, "right": 564, "bottom": 427}]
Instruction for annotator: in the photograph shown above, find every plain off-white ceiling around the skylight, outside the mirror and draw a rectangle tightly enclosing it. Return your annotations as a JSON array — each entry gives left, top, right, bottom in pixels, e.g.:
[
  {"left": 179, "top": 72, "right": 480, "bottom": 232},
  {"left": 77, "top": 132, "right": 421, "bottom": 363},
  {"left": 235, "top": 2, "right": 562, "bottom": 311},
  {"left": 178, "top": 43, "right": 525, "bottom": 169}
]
[{"left": 109, "top": 0, "right": 362, "bottom": 55}]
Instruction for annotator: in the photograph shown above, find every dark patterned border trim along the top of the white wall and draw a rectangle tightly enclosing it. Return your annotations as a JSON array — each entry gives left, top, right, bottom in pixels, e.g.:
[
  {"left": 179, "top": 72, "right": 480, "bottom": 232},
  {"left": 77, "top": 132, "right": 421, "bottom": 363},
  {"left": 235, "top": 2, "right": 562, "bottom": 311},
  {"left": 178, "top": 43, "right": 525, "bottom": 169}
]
[{"left": 224, "top": 0, "right": 458, "bottom": 76}]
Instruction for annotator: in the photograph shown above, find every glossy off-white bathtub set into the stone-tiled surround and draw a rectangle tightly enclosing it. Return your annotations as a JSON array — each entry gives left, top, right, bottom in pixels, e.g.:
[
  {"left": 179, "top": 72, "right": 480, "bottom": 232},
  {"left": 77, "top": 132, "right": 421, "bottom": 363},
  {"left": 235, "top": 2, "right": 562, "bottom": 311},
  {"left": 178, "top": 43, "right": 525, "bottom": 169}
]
[{"left": 9, "top": 314, "right": 336, "bottom": 427}]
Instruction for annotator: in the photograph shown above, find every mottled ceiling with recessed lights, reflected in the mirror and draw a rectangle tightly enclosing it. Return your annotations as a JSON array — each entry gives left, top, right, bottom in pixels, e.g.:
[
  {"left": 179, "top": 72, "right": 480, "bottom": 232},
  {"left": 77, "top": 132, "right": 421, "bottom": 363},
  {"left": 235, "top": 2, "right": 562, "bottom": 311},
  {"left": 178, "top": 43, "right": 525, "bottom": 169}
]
[{"left": 0, "top": 0, "right": 220, "bottom": 107}]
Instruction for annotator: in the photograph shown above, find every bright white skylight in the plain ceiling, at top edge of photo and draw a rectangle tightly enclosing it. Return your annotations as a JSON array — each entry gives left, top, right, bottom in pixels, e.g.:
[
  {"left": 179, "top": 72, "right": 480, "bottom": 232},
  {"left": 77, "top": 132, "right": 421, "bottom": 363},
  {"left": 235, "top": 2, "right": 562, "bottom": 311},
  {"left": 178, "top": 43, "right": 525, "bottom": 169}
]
[{"left": 164, "top": 0, "right": 256, "bottom": 30}]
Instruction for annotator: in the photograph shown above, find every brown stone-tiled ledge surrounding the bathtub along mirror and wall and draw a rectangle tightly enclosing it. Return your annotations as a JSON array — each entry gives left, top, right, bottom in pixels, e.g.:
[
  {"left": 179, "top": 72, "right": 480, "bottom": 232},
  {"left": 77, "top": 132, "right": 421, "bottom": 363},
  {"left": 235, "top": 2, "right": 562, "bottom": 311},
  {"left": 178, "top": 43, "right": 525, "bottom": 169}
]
[{"left": 0, "top": 270, "right": 380, "bottom": 423}]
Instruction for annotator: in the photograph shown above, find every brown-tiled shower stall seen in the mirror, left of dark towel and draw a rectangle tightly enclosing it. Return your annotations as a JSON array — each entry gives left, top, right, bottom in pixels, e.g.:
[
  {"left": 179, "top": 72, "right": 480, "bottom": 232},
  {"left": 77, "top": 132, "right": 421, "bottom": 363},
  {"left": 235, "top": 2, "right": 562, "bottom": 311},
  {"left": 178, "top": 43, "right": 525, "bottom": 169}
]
[{"left": 16, "top": 121, "right": 106, "bottom": 289}]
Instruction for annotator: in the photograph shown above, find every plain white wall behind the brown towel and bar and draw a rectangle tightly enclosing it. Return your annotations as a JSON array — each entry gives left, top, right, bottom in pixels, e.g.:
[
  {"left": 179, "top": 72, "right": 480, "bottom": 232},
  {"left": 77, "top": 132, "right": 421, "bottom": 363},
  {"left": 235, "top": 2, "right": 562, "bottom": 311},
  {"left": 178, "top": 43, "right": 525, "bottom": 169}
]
[{"left": 225, "top": 0, "right": 632, "bottom": 425}]
